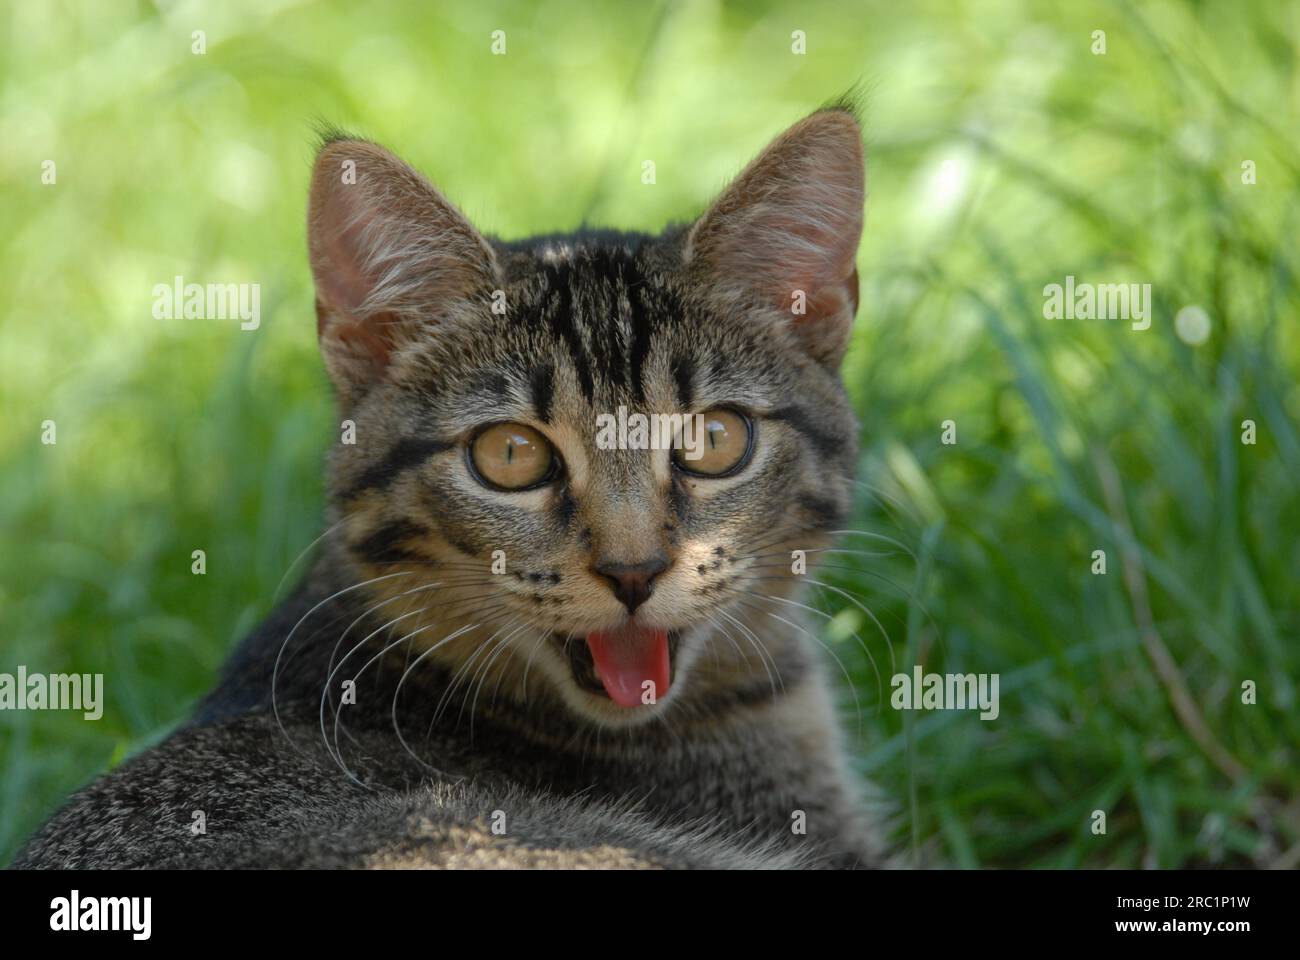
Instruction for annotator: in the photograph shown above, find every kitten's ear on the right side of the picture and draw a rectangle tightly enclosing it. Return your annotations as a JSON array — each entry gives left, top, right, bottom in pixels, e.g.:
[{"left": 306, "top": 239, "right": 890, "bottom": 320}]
[{"left": 686, "top": 108, "right": 866, "bottom": 367}]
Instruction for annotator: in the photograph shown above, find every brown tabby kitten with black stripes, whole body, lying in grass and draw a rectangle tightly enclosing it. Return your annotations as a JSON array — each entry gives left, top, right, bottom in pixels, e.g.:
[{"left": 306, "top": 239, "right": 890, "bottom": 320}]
[{"left": 16, "top": 105, "right": 881, "bottom": 868}]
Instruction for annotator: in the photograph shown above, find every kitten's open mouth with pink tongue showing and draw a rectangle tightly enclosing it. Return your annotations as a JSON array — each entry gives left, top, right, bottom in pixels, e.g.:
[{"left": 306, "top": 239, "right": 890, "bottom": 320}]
[{"left": 554, "top": 623, "right": 681, "bottom": 706}]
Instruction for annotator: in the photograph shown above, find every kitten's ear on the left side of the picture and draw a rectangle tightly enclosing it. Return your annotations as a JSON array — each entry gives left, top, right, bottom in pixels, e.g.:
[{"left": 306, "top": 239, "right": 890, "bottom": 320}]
[{"left": 307, "top": 139, "right": 497, "bottom": 403}]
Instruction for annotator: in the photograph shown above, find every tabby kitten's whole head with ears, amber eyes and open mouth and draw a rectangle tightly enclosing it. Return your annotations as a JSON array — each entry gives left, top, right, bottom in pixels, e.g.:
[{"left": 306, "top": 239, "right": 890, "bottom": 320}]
[{"left": 311, "top": 111, "right": 863, "bottom": 726}]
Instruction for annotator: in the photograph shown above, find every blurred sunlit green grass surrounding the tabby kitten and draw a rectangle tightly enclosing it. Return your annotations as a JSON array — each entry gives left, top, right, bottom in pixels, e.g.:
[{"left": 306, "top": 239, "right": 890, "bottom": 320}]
[{"left": 0, "top": 0, "right": 1300, "bottom": 866}]
